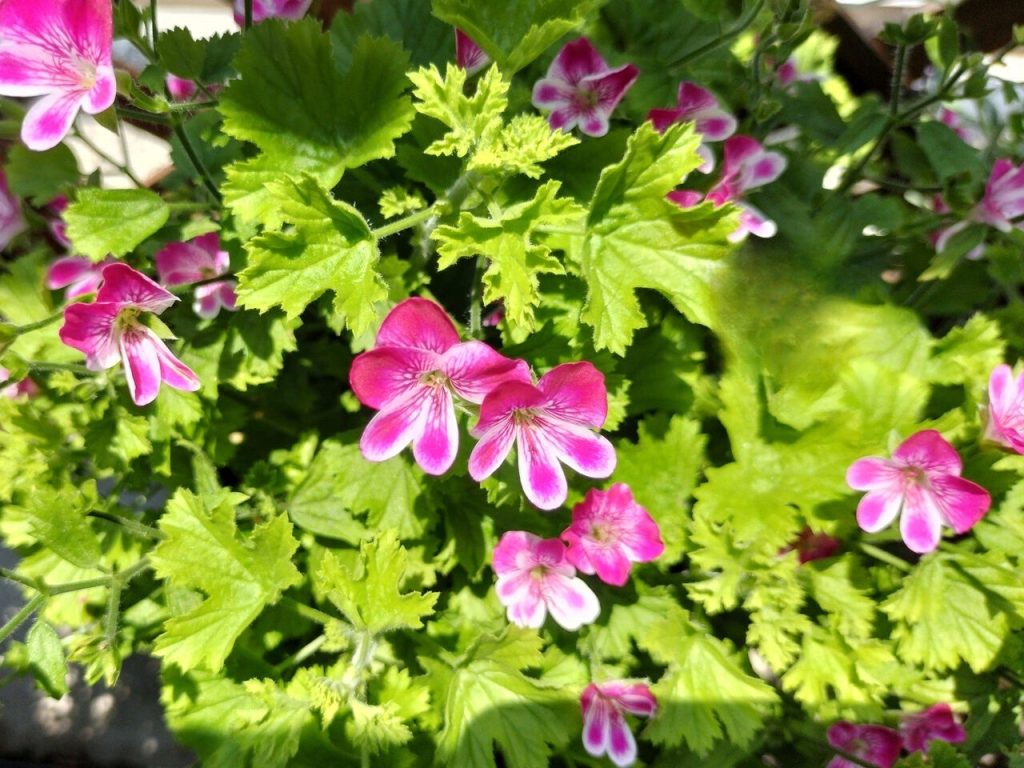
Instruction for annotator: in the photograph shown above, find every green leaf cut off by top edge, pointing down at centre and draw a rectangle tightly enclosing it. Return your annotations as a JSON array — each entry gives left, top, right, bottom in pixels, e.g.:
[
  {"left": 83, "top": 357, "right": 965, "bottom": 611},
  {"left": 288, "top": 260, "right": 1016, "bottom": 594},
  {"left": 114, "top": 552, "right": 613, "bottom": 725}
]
[{"left": 433, "top": 0, "right": 601, "bottom": 76}]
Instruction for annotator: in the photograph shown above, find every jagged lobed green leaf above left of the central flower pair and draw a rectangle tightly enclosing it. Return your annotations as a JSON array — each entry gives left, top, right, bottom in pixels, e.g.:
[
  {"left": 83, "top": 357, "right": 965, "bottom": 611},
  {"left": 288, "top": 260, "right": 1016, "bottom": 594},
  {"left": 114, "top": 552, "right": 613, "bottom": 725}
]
[{"left": 239, "top": 176, "right": 387, "bottom": 334}]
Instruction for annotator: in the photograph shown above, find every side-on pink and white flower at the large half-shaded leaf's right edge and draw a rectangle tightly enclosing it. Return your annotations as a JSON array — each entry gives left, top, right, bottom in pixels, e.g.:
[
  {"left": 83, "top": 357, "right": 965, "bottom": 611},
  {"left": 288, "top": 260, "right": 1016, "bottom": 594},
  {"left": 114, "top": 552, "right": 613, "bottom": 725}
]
[{"left": 668, "top": 135, "right": 786, "bottom": 243}]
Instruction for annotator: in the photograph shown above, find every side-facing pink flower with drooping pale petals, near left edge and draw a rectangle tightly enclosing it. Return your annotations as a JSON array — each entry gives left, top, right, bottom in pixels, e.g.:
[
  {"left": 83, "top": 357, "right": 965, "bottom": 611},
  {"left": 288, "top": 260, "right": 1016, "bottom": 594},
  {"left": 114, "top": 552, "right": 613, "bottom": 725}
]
[{"left": 60, "top": 263, "right": 200, "bottom": 406}]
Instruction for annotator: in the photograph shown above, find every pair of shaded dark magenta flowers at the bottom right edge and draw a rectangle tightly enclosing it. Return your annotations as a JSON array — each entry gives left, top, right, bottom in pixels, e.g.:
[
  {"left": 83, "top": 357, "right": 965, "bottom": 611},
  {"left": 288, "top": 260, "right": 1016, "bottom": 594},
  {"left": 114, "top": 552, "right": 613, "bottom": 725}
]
[{"left": 826, "top": 703, "right": 967, "bottom": 768}]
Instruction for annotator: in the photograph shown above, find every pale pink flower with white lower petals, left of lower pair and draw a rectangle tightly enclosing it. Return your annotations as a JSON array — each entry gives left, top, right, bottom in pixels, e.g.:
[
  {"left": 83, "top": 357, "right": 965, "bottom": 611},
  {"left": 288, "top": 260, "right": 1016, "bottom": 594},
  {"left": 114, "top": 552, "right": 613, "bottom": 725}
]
[{"left": 494, "top": 530, "right": 601, "bottom": 631}]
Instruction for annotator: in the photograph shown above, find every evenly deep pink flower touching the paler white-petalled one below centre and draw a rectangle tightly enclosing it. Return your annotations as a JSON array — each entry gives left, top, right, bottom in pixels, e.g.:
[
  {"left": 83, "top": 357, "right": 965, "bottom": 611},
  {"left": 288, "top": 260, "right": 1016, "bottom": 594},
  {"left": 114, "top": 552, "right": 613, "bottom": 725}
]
[{"left": 562, "top": 482, "right": 665, "bottom": 587}]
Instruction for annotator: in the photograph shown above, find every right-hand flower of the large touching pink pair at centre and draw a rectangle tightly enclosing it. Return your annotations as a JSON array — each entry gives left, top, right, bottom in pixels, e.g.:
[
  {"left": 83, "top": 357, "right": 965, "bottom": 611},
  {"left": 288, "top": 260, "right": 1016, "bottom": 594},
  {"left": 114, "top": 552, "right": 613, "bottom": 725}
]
[{"left": 469, "top": 362, "right": 615, "bottom": 509}]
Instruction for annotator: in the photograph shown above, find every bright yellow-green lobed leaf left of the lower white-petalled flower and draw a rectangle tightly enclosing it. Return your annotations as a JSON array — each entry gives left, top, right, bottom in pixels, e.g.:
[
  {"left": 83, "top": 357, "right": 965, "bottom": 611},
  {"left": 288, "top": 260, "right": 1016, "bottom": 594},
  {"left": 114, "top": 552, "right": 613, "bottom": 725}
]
[{"left": 314, "top": 530, "right": 437, "bottom": 635}]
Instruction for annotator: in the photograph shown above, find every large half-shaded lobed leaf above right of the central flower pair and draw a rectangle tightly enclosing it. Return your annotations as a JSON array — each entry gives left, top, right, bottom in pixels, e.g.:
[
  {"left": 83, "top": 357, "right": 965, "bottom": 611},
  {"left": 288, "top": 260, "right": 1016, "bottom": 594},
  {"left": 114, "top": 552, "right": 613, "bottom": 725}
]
[{"left": 579, "top": 123, "right": 735, "bottom": 354}]
